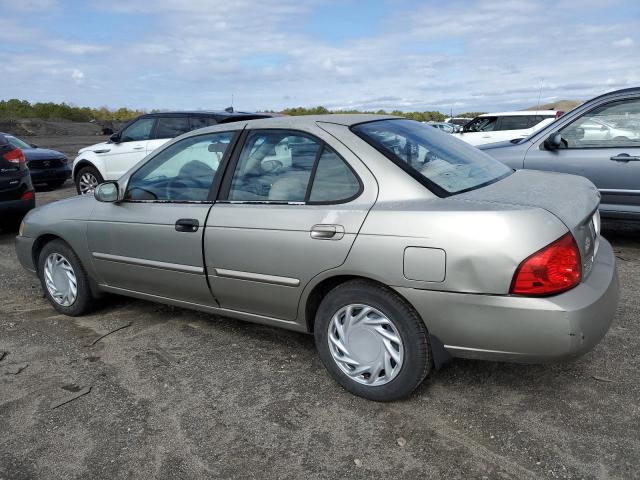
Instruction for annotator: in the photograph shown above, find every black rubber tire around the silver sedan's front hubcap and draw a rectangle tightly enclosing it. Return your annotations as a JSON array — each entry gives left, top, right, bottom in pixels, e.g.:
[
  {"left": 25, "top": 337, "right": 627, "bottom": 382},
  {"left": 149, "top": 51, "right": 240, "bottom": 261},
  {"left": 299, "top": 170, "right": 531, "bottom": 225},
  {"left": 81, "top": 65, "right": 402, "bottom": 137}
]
[{"left": 38, "top": 239, "right": 94, "bottom": 317}]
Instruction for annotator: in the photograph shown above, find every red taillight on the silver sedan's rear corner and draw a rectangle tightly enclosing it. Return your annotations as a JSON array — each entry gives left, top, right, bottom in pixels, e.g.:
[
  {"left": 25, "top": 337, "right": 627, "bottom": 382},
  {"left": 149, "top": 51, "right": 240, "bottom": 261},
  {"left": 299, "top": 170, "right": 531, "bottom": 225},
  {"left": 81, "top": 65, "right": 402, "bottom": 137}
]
[{"left": 511, "top": 233, "right": 582, "bottom": 296}]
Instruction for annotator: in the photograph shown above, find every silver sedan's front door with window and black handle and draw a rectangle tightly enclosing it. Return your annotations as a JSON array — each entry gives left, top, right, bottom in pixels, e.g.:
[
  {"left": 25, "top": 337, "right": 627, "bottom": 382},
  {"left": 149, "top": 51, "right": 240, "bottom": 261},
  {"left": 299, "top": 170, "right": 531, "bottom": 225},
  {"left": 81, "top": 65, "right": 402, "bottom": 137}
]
[{"left": 87, "top": 132, "right": 236, "bottom": 304}]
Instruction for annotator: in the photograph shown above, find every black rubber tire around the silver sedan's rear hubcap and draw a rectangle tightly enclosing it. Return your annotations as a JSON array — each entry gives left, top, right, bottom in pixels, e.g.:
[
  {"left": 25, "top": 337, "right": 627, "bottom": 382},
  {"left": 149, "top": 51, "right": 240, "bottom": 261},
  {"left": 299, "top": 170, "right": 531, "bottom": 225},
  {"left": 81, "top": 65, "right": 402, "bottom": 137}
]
[{"left": 314, "top": 280, "right": 433, "bottom": 402}]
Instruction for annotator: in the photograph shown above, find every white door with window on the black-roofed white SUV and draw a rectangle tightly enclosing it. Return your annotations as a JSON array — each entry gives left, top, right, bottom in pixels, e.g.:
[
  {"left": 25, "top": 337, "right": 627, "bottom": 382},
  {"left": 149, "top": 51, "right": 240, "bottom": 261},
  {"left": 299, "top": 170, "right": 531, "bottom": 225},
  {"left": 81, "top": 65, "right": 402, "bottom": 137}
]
[{"left": 104, "top": 117, "right": 156, "bottom": 180}]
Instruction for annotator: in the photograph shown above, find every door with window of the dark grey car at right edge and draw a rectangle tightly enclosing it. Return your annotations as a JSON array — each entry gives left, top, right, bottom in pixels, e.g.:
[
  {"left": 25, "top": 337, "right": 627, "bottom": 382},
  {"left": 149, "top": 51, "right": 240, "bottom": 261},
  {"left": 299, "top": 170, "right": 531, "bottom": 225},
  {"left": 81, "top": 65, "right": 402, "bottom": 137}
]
[{"left": 524, "top": 97, "right": 640, "bottom": 213}]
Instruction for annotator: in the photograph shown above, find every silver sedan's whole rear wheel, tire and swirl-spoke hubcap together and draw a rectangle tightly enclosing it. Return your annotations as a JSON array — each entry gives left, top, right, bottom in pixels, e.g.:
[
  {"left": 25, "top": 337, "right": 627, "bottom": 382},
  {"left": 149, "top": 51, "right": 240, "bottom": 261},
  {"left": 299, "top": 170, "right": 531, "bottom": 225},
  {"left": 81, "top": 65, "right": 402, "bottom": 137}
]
[{"left": 314, "top": 280, "right": 432, "bottom": 401}]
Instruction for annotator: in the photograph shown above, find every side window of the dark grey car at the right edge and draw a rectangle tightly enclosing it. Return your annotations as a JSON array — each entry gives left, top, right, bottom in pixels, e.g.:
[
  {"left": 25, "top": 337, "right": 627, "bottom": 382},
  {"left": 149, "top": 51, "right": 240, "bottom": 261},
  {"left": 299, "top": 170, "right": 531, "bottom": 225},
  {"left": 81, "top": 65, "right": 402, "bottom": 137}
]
[{"left": 560, "top": 99, "right": 640, "bottom": 148}]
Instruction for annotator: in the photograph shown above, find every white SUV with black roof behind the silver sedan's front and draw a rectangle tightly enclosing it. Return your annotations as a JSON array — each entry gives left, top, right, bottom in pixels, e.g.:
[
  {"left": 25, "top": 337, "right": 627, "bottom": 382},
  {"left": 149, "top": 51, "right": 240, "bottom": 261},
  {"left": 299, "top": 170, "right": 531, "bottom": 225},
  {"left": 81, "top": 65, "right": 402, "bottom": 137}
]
[{"left": 73, "top": 111, "right": 270, "bottom": 195}]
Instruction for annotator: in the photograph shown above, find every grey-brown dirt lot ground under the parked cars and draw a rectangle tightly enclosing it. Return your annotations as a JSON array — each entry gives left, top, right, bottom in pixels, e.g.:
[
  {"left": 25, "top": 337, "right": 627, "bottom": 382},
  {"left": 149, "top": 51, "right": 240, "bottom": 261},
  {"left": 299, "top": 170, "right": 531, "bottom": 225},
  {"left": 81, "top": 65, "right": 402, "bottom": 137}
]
[{"left": 0, "top": 137, "right": 640, "bottom": 479}]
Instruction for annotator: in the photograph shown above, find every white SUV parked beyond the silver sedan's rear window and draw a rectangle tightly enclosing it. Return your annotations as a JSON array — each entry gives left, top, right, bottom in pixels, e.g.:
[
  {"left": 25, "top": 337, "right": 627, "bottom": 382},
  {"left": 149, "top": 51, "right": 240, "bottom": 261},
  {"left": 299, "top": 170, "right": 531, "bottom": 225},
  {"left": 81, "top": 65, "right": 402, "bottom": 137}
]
[{"left": 455, "top": 110, "right": 564, "bottom": 146}]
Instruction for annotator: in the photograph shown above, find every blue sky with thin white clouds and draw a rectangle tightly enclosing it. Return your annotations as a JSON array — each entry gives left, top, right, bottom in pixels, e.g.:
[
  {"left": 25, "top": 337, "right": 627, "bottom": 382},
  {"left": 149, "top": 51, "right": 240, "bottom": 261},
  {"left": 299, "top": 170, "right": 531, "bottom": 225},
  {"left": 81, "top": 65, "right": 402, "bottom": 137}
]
[{"left": 0, "top": 0, "right": 640, "bottom": 114}]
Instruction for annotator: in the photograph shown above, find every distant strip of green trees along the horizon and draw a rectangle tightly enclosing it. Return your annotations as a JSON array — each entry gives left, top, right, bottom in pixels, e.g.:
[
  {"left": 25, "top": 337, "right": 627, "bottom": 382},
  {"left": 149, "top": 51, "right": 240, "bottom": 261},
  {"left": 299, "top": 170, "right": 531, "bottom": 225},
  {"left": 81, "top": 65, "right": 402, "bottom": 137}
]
[{"left": 0, "top": 98, "right": 481, "bottom": 122}]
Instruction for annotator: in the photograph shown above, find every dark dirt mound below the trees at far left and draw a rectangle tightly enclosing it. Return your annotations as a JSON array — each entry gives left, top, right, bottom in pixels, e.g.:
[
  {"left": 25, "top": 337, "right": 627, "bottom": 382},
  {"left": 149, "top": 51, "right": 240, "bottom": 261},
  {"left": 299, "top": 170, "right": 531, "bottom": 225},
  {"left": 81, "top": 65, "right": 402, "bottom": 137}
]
[{"left": 0, "top": 118, "right": 123, "bottom": 137}]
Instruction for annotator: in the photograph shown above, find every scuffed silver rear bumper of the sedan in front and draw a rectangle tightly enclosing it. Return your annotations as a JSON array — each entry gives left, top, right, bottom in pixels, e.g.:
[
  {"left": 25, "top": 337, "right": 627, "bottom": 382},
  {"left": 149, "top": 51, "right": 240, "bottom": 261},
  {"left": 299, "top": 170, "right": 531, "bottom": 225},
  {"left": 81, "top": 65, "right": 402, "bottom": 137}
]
[{"left": 396, "top": 239, "right": 619, "bottom": 363}]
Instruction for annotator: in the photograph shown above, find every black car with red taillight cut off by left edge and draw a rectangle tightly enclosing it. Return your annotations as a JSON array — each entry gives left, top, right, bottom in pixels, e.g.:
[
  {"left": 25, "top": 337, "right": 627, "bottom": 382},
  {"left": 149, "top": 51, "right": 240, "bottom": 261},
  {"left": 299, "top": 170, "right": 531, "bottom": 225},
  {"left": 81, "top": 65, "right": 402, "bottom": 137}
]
[{"left": 0, "top": 133, "right": 35, "bottom": 230}]
